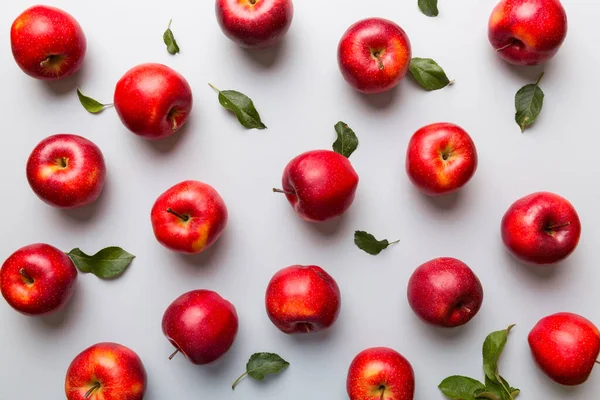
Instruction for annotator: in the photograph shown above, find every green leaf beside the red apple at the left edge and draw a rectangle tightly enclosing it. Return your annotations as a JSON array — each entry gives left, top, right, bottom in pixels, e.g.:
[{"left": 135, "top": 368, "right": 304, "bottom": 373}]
[{"left": 67, "top": 247, "right": 135, "bottom": 279}]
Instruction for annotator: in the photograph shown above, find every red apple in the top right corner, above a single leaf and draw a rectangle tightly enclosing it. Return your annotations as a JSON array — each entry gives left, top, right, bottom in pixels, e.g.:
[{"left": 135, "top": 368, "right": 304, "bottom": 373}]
[{"left": 488, "top": 0, "right": 567, "bottom": 65}]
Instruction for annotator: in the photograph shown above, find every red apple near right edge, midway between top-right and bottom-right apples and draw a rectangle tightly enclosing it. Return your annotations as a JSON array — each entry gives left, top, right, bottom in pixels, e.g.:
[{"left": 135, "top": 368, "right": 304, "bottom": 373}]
[{"left": 501, "top": 192, "right": 581, "bottom": 264}]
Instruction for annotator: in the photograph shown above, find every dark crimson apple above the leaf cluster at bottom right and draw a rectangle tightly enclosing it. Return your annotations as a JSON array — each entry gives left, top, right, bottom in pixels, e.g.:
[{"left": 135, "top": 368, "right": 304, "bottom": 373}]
[{"left": 408, "top": 257, "right": 483, "bottom": 328}]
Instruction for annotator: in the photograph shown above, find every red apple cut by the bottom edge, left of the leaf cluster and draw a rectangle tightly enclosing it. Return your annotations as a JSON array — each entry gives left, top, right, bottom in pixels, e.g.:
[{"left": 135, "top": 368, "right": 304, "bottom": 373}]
[{"left": 346, "top": 347, "right": 415, "bottom": 400}]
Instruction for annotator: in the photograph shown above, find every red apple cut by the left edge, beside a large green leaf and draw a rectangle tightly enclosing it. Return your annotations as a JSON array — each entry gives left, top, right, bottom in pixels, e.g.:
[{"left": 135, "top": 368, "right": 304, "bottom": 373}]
[{"left": 0, "top": 243, "right": 77, "bottom": 316}]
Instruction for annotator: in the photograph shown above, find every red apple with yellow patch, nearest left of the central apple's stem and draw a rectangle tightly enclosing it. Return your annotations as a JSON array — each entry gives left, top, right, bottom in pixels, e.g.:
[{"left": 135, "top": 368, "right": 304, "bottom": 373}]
[{"left": 150, "top": 181, "right": 227, "bottom": 254}]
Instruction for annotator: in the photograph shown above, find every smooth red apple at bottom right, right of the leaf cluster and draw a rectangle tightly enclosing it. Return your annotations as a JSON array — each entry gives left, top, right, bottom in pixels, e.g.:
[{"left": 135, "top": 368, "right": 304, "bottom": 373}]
[{"left": 528, "top": 313, "right": 600, "bottom": 386}]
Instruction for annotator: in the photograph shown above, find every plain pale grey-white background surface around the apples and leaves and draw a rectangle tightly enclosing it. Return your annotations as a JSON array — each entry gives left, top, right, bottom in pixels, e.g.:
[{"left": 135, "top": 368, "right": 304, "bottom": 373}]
[{"left": 0, "top": 0, "right": 600, "bottom": 400}]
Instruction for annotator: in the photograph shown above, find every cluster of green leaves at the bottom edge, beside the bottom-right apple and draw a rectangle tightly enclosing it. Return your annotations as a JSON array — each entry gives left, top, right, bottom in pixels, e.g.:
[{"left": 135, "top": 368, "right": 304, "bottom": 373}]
[{"left": 438, "top": 325, "right": 520, "bottom": 400}]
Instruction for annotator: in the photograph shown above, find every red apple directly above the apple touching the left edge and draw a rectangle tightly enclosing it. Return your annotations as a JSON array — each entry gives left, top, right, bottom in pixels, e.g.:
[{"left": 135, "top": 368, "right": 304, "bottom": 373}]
[{"left": 27, "top": 134, "right": 106, "bottom": 208}]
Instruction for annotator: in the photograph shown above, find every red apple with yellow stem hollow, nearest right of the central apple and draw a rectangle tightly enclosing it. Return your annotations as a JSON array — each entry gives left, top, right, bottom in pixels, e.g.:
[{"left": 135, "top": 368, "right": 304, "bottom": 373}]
[{"left": 406, "top": 122, "right": 477, "bottom": 196}]
